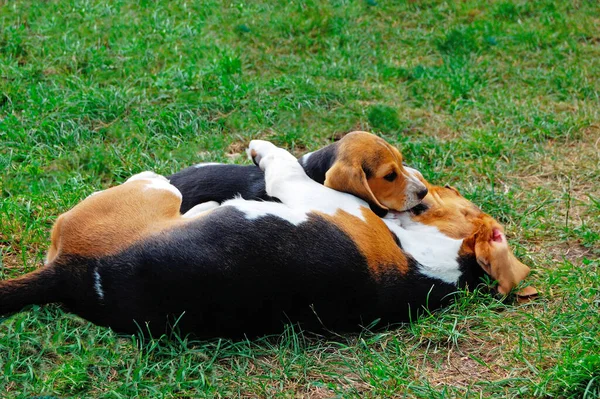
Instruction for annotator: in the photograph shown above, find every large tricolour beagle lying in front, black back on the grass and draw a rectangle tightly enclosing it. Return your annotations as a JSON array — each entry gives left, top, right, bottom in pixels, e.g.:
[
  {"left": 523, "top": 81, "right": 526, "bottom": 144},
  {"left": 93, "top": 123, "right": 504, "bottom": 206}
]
[{"left": 0, "top": 141, "right": 536, "bottom": 338}]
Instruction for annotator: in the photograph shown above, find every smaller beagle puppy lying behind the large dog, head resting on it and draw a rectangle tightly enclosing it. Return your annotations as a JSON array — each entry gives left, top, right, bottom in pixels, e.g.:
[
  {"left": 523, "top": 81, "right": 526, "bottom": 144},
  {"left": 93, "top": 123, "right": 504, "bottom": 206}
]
[{"left": 169, "top": 132, "right": 427, "bottom": 216}]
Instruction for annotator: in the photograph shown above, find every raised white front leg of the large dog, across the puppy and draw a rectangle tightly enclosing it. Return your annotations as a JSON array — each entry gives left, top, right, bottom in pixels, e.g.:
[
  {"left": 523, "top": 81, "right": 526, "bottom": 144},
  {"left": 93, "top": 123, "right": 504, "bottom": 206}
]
[{"left": 248, "top": 140, "right": 368, "bottom": 218}]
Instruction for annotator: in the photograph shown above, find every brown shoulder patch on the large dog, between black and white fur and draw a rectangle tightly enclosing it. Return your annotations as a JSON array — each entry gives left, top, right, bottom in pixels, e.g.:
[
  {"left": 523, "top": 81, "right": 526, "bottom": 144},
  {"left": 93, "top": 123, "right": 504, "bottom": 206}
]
[{"left": 315, "top": 208, "right": 408, "bottom": 277}]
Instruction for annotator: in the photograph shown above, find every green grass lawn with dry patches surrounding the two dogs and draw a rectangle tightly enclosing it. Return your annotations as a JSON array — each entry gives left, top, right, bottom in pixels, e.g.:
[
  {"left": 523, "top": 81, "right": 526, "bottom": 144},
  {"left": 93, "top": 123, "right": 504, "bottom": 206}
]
[{"left": 0, "top": 0, "right": 600, "bottom": 399}]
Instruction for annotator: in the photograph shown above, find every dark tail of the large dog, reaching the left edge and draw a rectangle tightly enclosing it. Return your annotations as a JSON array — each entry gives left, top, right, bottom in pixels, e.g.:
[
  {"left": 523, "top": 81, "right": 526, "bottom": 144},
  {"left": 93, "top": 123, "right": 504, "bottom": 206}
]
[{"left": 0, "top": 264, "right": 62, "bottom": 315}]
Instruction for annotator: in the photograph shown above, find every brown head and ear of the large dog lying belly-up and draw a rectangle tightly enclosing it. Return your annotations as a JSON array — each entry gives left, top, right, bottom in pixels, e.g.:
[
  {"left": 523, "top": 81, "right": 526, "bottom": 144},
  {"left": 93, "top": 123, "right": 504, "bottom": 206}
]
[{"left": 404, "top": 177, "right": 537, "bottom": 297}]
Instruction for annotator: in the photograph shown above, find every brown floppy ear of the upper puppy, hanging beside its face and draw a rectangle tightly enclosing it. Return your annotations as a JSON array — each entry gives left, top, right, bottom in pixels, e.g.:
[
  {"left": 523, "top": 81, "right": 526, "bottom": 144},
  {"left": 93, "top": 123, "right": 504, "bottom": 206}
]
[{"left": 324, "top": 161, "right": 389, "bottom": 211}]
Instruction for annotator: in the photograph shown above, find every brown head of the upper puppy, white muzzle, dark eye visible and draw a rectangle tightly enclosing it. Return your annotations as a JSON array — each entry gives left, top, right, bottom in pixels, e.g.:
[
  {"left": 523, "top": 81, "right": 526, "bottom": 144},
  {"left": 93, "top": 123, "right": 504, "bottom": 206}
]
[{"left": 324, "top": 132, "right": 427, "bottom": 214}]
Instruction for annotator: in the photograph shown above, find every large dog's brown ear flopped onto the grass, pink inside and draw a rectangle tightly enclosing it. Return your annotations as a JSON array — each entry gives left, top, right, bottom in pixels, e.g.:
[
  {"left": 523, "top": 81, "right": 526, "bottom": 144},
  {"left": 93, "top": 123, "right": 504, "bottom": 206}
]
[{"left": 463, "top": 219, "right": 537, "bottom": 295}]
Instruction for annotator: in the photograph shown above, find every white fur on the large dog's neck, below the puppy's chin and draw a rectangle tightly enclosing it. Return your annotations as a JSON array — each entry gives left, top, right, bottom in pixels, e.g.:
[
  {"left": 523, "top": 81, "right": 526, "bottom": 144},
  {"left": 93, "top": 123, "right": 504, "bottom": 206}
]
[{"left": 383, "top": 217, "right": 463, "bottom": 285}]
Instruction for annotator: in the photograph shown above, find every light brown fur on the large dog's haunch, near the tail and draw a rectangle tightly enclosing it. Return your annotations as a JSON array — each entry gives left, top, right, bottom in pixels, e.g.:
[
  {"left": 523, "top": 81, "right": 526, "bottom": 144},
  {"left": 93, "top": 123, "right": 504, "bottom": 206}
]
[{"left": 48, "top": 180, "right": 191, "bottom": 261}]
